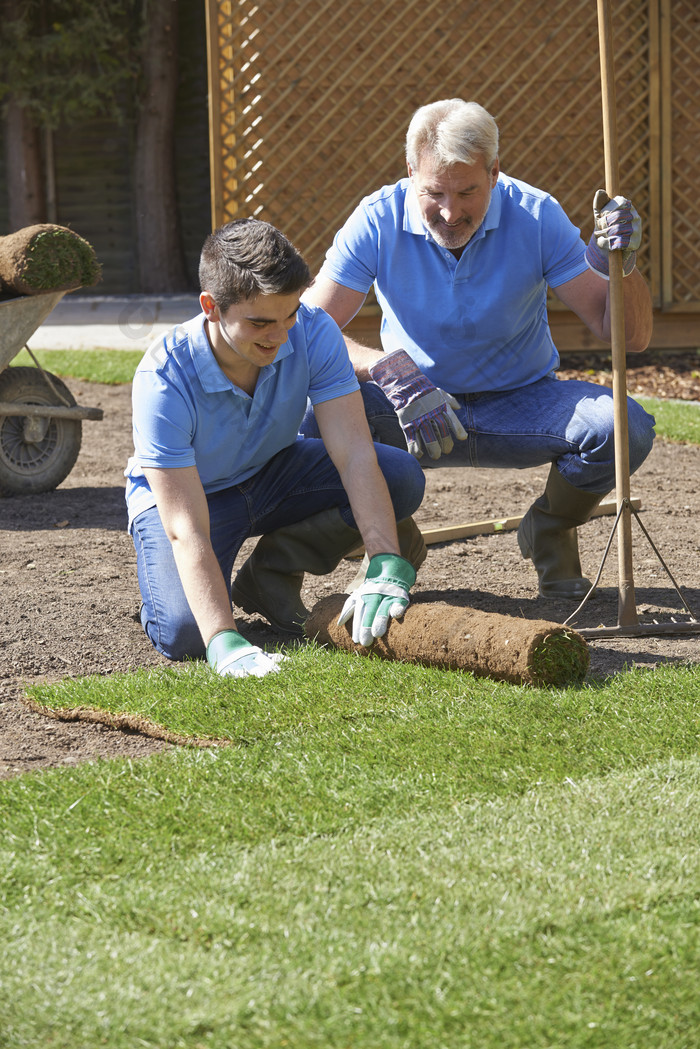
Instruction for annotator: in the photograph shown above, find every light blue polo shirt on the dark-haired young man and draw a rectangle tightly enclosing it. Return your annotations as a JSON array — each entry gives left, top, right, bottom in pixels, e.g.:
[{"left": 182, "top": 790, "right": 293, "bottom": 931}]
[{"left": 125, "top": 303, "right": 359, "bottom": 528}]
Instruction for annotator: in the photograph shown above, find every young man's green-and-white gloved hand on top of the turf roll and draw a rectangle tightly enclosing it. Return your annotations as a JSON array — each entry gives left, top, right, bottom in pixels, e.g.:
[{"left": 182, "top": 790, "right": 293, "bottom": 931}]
[{"left": 338, "top": 554, "right": 416, "bottom": 647}]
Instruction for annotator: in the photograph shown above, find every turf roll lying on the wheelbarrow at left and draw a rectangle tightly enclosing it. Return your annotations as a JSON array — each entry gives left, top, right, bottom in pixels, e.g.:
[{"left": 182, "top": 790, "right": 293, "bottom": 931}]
[{"left": 0, "top": 222, "right": 101, "bottom": 297}]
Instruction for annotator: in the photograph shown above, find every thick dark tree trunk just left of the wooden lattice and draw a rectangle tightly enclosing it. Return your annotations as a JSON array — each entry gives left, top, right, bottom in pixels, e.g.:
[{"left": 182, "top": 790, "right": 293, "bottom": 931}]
[{"left": 134, "top": 0, "right": 188, "bottom": 294}]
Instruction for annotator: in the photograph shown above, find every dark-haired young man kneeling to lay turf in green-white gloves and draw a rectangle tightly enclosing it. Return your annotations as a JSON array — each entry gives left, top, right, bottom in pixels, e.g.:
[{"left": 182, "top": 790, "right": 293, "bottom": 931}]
[{"left": 126, "top": 219, "right": 425, "bottom": 677}]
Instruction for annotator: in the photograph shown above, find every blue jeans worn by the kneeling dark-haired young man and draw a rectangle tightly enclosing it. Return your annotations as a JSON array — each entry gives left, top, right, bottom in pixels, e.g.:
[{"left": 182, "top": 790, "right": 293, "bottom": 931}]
[{"left": 132, "top": 441, "right": 425, "bottom": 660}]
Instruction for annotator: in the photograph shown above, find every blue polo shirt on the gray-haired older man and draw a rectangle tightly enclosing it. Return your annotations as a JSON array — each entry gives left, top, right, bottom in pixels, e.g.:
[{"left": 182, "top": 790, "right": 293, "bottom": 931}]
[{"left": 321, "top": 173, "right": 587, "bottom": 393}]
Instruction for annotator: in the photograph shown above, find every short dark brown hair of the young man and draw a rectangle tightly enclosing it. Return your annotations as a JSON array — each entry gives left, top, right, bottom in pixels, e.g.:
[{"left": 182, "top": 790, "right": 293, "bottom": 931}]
[{"left": 199, "top": 218, "right": 311, "bottom": 313}]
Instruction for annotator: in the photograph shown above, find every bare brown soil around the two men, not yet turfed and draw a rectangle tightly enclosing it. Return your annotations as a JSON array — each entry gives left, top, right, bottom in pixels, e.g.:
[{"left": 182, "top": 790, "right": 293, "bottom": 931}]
[{"left": 0, "top": 354, "right": 700, "bottom": 778}]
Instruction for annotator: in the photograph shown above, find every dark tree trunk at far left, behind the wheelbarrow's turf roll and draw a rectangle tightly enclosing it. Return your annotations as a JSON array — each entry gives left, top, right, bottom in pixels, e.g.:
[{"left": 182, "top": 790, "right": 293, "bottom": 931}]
[{"left": 5, "top": 102, "right": 46, "bottom": 233}]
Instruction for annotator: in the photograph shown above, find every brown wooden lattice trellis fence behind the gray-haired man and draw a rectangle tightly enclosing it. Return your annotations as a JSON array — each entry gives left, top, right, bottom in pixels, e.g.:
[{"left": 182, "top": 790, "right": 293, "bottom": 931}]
[{"left": 207, "top": 0, "right": 700, "bottom": 339}]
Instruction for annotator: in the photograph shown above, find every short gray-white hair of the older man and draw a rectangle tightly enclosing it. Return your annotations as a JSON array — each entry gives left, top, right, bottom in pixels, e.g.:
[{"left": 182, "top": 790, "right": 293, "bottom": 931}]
[{"left": 406, "top": 99, "right": 499, "bottom": 170}]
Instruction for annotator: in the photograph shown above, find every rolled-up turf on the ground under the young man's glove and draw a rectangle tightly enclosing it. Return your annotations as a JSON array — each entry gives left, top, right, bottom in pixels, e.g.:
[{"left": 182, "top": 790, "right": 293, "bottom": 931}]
[{"left": 304, "top": 594, "right": 589, "bottom": 686}]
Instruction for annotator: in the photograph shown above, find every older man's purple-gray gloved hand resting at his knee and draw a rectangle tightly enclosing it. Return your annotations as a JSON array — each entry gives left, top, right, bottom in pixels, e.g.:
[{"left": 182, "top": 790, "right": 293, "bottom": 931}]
[{"left": 369, "top": 349, "right": 467, "bottom": 459}]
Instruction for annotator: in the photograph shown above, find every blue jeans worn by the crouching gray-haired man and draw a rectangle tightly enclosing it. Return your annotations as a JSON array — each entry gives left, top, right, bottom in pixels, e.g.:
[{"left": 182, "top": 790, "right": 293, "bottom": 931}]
[{"left": 300, "top": 373, "right": 654, "bottom": 495}]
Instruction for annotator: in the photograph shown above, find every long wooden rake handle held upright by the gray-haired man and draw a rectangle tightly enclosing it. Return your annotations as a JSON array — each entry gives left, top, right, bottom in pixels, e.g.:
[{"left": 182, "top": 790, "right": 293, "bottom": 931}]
[{"left": 597, "top": 0, "right": 638, "bottom": 626}]
